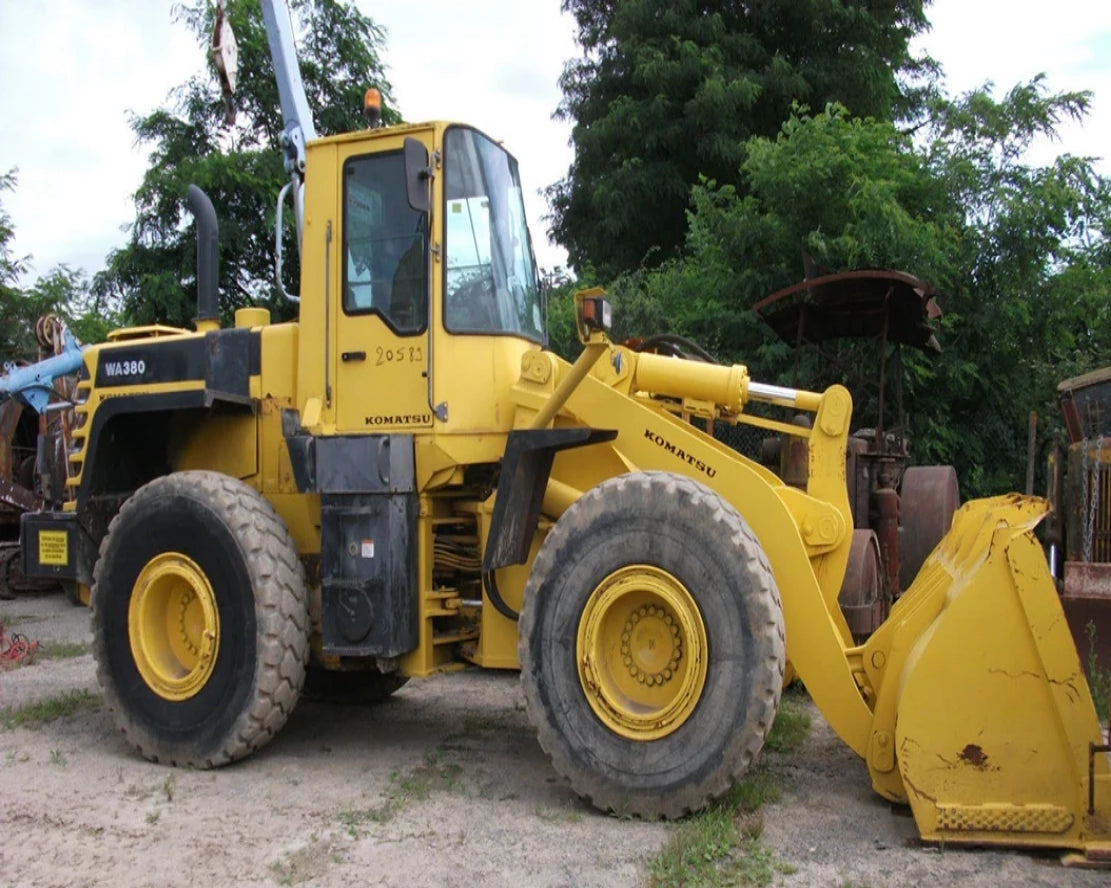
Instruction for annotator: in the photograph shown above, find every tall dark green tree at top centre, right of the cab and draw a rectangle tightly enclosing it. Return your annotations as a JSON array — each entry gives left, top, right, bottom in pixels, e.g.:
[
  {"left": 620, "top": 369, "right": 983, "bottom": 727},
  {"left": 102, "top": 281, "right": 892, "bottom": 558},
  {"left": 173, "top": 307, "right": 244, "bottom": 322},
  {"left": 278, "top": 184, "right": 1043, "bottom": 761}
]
[{"left": 548, "top": 0, "right": 934, "bottom": 276}]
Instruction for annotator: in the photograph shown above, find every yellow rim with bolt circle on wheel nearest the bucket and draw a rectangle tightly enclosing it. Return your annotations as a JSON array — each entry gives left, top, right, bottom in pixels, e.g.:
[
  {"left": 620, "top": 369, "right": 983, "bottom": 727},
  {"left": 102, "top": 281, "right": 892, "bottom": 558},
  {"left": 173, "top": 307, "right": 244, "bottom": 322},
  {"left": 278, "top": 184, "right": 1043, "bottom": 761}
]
[{"left": 575, "top": 565, "right": 709, "bottom": 740}]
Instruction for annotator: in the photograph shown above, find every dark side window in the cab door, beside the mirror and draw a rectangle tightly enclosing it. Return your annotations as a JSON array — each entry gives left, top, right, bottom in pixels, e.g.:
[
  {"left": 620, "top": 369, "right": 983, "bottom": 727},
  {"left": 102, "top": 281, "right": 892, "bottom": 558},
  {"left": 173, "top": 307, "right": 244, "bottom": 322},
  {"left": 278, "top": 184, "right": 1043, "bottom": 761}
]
[{"left": 343, "top": 151, "right": 428, "bottom": 336}]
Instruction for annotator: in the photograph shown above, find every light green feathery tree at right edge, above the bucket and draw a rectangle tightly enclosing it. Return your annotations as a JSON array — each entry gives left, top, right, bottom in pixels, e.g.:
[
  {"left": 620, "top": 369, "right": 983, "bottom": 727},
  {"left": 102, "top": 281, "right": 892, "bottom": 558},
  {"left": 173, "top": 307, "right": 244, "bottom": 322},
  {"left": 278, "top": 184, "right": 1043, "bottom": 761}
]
[{"left": 919, "top": 78, "right": 1111, "bottom": 492}]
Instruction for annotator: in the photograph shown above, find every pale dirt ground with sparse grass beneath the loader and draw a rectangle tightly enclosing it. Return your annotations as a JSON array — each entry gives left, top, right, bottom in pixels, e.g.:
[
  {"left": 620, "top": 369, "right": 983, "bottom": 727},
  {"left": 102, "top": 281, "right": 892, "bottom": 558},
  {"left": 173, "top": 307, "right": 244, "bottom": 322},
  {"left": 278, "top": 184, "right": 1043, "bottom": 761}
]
[{"left": 0, "top": 596, "right": 1108, "bottom": 888}]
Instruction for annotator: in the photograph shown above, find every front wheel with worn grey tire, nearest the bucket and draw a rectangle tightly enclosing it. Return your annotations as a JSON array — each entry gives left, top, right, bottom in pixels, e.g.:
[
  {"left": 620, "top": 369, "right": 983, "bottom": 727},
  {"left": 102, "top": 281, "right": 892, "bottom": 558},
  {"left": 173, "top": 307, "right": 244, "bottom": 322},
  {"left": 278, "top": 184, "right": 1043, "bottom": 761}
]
[{"left": 518, "top": 472, "right": 784, "bottom": 818}]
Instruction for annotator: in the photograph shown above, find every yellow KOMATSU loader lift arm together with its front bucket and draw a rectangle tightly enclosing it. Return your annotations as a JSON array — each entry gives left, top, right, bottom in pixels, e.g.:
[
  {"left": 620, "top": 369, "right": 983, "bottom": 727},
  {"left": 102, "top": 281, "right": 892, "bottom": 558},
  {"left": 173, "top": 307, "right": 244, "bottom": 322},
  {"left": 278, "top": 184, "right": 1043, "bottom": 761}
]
[{"left": 513, "top": 347, "right": 1111, "bottom": 859}]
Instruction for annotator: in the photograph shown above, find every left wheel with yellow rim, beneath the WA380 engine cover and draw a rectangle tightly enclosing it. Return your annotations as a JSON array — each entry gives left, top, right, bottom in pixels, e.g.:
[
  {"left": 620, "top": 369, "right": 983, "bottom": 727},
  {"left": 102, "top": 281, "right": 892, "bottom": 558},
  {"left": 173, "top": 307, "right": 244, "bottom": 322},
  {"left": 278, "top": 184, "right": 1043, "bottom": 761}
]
[{"left": 91, "top": 471, "right": 309, "bottom": 768}]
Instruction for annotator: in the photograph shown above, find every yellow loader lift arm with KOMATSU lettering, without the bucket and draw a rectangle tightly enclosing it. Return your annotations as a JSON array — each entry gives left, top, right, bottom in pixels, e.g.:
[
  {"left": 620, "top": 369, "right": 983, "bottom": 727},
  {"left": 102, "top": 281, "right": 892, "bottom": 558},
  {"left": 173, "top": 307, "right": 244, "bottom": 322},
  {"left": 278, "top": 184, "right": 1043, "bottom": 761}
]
[{"left": 513, "top": 347, "right": 871, "bottom": 756}]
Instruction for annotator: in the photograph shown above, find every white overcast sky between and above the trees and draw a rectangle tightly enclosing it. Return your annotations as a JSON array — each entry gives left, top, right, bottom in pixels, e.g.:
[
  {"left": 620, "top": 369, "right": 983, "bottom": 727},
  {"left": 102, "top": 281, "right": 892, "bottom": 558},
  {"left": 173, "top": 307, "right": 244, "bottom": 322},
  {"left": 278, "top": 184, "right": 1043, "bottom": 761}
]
[{"left": 0, "top": 0, "right": 1111, "bottom": 282}]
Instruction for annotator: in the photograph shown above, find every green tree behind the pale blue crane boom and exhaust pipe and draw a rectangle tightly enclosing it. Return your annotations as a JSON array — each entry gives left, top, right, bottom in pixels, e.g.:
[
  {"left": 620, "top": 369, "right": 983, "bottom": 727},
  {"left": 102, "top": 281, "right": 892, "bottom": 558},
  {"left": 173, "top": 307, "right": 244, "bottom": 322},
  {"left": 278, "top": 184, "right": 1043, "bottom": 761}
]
[{"left": 93, "top": 0, "right": 400, "bottom": 327}]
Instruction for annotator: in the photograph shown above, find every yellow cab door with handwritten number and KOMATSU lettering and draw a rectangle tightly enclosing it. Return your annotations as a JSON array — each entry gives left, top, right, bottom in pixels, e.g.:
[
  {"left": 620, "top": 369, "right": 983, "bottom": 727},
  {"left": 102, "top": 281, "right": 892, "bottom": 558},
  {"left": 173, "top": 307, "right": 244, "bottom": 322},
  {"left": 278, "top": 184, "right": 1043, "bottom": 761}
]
[{"left": 333, "top": 138, "right": 432, "bottom": 432}]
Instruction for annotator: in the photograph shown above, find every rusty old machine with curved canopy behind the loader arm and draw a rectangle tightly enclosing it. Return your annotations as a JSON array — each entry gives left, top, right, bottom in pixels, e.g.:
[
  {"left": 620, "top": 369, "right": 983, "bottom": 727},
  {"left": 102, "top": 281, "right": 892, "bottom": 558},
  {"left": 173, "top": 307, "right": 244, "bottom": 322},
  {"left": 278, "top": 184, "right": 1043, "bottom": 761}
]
[{"left": 754, "top": 267, "right": 960, "bottom": 641}]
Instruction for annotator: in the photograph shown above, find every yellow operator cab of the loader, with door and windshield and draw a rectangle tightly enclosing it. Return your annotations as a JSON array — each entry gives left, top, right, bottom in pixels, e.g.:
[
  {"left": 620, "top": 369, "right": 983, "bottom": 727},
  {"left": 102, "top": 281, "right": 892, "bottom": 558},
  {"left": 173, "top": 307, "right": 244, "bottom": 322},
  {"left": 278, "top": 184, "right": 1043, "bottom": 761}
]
[{"left": 322, "top": 122, "right": 547, "bottom": 437}]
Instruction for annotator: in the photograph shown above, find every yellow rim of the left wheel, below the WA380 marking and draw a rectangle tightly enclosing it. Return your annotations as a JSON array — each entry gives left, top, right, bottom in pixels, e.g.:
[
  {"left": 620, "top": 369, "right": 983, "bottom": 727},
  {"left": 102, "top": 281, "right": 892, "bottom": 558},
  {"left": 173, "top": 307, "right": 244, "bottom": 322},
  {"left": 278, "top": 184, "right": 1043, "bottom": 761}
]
[{"left": 128, "top": 552, "right": 220, "bottom": 701}]
